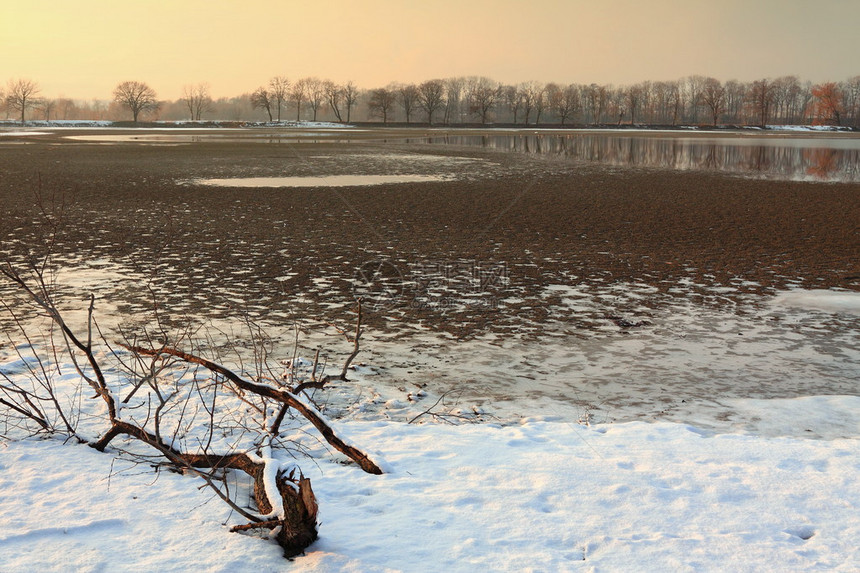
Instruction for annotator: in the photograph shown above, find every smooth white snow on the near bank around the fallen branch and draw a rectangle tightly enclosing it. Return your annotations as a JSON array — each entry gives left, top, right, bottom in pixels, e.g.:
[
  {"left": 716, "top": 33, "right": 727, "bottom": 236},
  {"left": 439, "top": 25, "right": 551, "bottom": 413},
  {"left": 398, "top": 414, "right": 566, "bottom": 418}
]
[{"left": 0, "top": 414, "right": 860, "bottom": 572}]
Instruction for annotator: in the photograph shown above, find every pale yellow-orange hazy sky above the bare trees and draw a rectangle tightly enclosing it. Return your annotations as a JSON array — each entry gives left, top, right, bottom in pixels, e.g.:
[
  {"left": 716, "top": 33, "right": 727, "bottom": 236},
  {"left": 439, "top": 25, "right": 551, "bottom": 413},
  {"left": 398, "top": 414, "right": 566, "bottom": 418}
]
[{"left": 0, "top": 0, "right": 860, "bottom": 99}]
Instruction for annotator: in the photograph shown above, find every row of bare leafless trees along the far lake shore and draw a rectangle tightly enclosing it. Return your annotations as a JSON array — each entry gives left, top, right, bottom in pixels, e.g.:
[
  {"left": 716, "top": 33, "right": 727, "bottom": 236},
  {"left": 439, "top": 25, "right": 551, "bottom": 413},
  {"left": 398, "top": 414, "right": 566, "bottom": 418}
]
[{"left": 0, "top": 76, "right": 860, "bottom": 127}]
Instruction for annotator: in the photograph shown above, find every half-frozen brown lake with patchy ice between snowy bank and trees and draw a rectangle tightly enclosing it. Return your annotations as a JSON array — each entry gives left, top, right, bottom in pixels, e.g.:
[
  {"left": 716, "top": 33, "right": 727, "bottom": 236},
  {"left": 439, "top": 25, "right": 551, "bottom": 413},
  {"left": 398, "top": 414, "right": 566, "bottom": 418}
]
[{"left": 0, "top": 129, "right": 860, "bottom": 436}]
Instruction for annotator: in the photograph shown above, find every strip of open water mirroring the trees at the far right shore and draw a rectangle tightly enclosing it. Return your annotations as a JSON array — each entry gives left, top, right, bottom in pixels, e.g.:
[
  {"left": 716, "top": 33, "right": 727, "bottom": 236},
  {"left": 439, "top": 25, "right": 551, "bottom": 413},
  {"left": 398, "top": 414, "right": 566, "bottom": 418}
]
[{"left": 416, "top": 134, "right": 860, "bottom": 182}]
